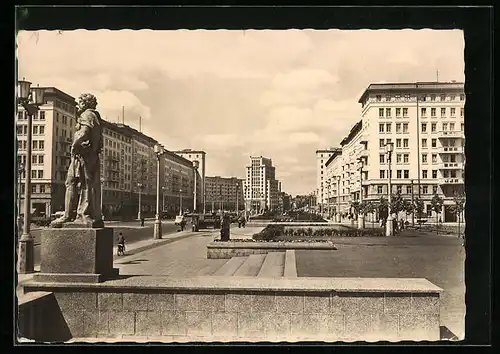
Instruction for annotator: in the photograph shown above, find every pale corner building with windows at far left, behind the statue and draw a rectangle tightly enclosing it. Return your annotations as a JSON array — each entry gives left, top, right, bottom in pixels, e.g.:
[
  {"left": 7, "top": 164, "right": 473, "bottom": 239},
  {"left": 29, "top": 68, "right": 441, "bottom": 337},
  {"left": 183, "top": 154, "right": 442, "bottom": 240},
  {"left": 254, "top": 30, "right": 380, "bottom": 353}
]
[{"left": 16, "top": 87, "right": 76, "bottom": 216}]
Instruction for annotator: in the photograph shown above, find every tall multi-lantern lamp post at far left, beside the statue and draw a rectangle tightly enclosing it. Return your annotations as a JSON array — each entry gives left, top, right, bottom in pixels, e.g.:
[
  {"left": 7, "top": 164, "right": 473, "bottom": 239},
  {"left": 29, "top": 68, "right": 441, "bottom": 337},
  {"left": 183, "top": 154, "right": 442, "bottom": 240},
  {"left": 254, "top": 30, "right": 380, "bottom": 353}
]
[{"left": 17, "top": 78, "right": 44, "bottom": 274}]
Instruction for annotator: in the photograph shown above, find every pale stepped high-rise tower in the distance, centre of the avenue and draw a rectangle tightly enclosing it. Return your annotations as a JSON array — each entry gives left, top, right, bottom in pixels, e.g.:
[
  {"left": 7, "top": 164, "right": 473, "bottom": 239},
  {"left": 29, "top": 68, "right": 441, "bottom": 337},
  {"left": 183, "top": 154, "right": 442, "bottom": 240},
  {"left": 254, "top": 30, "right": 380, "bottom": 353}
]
[{"left": 243, "top": 156, "right": 279, "bottom": 212}]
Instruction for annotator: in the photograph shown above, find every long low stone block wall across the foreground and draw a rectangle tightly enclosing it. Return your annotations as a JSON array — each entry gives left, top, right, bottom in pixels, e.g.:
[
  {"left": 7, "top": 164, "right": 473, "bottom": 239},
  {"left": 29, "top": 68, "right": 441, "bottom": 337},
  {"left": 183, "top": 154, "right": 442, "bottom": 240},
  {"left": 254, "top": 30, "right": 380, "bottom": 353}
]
[{"left": 21, "top": 277, "right": 439, "bottom": 341}]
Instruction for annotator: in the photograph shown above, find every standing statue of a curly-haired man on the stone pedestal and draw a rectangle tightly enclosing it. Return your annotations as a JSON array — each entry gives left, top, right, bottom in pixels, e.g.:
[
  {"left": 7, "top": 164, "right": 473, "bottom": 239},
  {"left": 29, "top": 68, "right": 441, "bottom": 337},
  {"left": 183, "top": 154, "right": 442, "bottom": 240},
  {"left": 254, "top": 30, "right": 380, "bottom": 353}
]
[{"left": 52, "top": 93, "right": 103, "bottom": 227}]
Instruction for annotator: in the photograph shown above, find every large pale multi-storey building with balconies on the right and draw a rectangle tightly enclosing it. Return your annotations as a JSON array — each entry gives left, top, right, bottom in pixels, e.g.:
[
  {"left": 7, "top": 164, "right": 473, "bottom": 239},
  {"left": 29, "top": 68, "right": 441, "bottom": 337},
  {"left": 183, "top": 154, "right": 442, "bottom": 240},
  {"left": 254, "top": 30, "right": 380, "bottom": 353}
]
[{"left": 328, "top": 82, "right": 465, "bottom": 221}]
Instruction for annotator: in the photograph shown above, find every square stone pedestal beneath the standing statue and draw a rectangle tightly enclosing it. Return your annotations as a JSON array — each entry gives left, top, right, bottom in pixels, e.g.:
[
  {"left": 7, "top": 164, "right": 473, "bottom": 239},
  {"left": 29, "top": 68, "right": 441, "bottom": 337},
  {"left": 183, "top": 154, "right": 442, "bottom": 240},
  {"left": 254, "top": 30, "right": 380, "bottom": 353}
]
[{"left": 33, "top": 225, "right": 118, "bottom": 283}]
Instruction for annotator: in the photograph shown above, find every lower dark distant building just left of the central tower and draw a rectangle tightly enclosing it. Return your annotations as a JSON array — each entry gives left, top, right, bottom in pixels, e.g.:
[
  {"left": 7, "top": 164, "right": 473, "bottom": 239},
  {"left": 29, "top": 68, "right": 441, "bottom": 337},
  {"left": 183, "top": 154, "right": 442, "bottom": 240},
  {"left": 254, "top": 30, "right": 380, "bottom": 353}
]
[{"left": 205, "top": 176, "right": 245, "bottom": 211}]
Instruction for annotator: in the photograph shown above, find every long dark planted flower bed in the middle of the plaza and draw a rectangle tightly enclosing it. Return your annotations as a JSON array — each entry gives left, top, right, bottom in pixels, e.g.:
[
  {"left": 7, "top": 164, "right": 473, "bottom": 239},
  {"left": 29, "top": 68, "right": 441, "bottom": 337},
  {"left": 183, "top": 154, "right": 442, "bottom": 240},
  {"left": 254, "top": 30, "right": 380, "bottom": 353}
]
[{"left": 252, "top": 224, "right": 384, "bottom": 242}]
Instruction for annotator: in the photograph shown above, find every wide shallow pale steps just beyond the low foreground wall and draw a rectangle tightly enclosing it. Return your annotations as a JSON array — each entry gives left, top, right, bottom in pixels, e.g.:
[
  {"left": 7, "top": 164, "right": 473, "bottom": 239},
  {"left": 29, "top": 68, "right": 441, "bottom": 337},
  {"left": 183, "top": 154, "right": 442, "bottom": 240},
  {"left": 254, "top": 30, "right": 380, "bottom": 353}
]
[{"left": 208, "top": 250, "right": 297, "bottom": 278}]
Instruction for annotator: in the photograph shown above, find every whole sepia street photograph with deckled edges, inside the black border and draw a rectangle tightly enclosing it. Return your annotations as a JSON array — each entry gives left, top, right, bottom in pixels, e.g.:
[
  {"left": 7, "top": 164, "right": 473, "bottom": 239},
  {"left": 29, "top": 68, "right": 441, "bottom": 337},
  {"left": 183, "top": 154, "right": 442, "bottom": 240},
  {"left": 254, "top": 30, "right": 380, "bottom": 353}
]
[{"left": 13, "top": 5, "right": 492, "bottom": 343}]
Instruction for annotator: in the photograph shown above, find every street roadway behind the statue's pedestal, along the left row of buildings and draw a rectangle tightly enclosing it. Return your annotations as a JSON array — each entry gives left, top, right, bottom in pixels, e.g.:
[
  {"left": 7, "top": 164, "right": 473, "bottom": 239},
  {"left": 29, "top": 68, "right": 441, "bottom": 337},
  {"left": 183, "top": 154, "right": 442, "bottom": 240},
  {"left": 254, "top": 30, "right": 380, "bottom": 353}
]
[{"left": 31, "top": 220, "right": 180, "bottom": 266}]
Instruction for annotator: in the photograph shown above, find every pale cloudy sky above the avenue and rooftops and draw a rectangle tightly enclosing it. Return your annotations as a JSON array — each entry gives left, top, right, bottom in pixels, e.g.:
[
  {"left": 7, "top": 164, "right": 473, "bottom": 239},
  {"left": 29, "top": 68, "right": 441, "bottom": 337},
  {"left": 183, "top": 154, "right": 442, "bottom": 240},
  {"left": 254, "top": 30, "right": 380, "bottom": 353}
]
[{"left": 17, "top": 30, "right": 465, "bottom": 195}]
